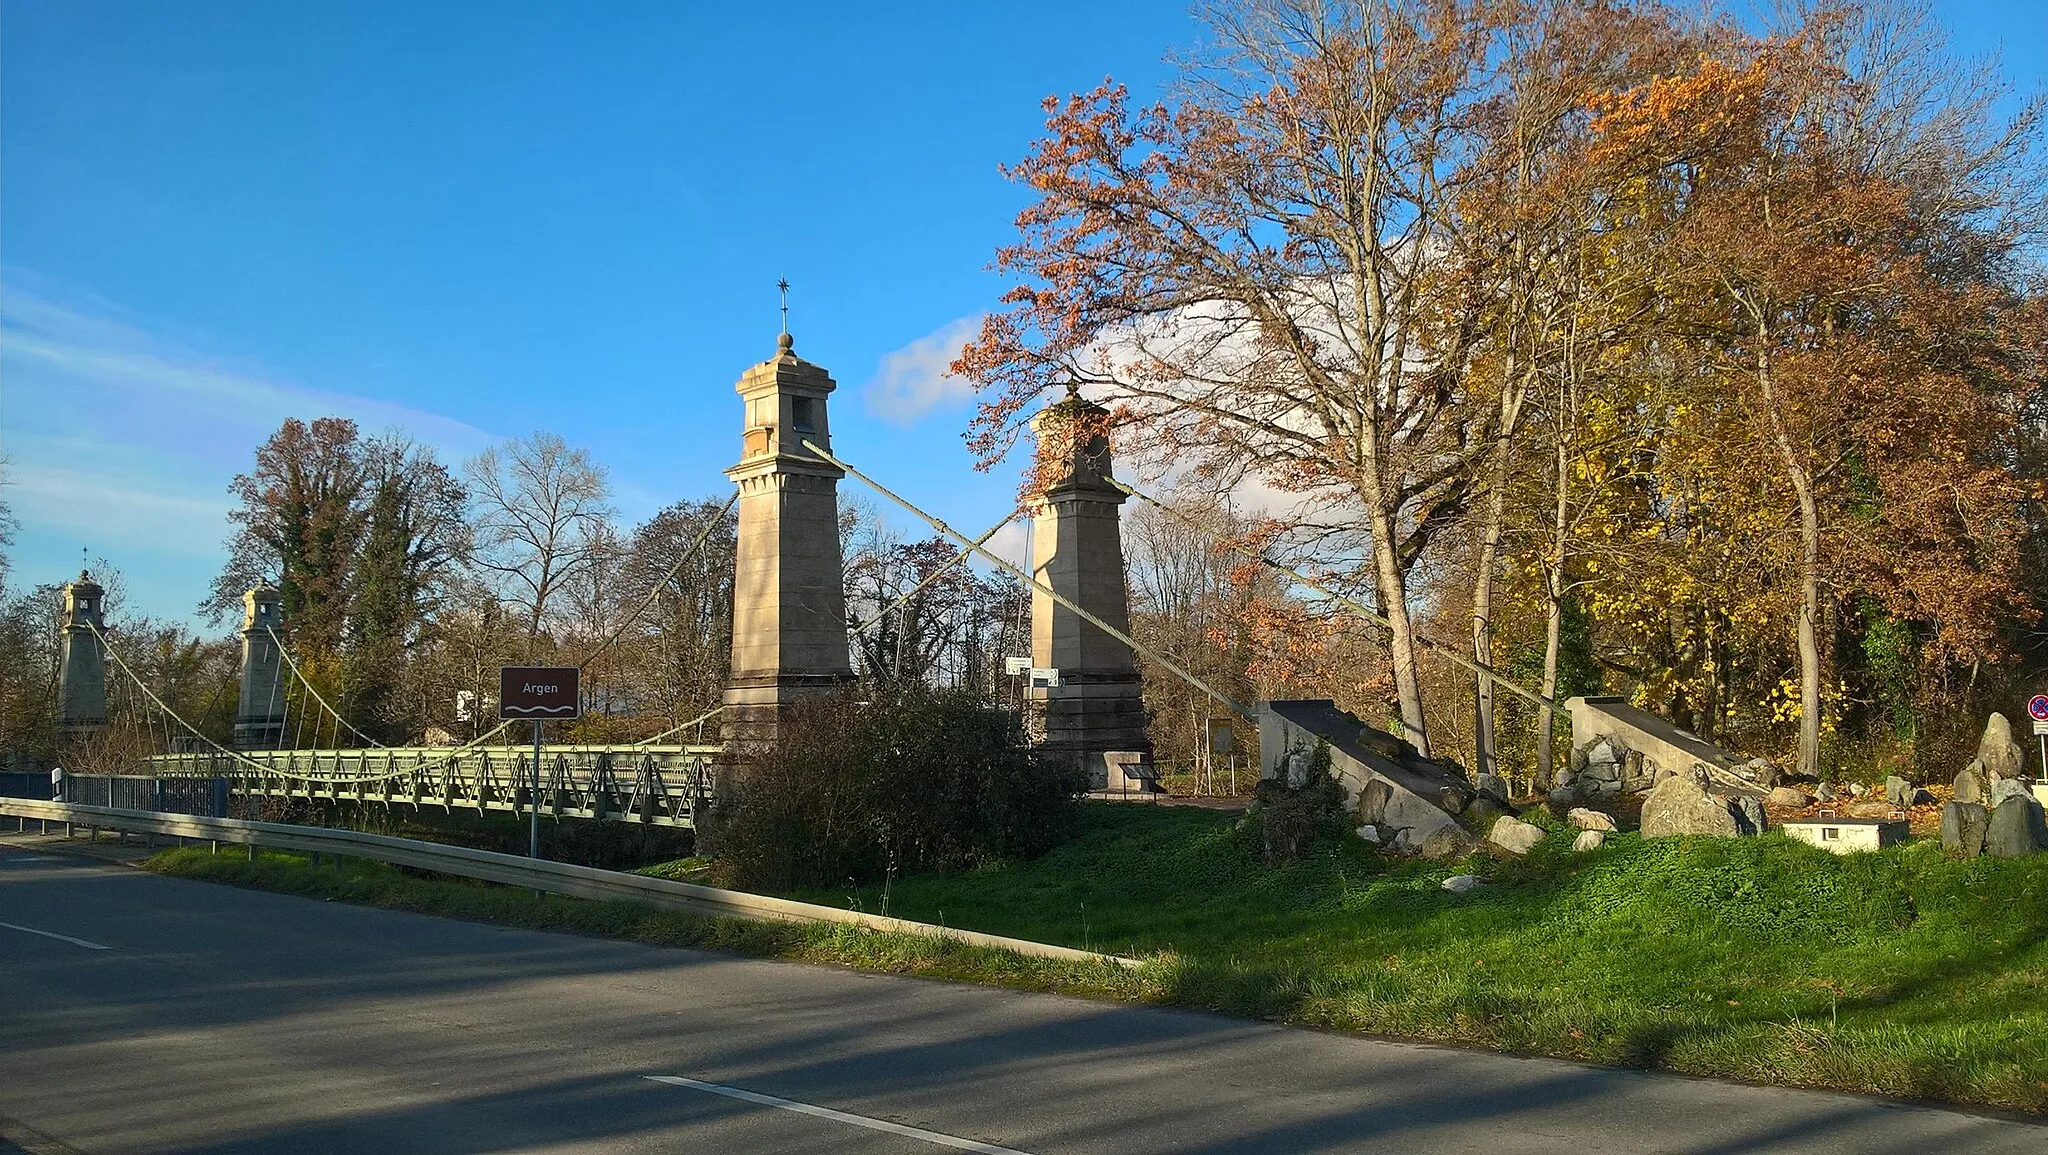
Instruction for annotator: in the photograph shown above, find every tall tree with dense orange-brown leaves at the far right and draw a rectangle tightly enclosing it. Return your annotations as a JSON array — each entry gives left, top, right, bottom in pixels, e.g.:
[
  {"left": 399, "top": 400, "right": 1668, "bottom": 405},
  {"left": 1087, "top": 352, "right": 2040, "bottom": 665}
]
[{"left": 1593, "top": 12, "right": 2032, "bottom": 774}]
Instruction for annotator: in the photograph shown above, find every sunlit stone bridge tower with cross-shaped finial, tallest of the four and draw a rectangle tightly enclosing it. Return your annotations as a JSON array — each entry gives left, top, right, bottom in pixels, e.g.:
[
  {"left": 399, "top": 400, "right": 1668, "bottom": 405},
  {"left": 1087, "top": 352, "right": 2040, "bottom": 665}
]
[{"left": 725, "top": 332, "right": 854, "bottom": 745}]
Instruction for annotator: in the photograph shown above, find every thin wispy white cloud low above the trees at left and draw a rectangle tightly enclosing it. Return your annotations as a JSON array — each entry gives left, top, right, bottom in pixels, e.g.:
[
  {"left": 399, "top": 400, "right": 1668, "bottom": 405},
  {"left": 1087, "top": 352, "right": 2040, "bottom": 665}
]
[{"left": 0, "top": 278, "right": 496, "bottom": 616}]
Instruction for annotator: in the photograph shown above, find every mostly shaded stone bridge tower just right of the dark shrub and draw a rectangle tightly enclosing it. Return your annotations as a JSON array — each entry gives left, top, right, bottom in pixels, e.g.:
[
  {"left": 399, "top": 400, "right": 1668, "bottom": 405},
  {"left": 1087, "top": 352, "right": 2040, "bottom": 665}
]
[{"left": 1030, "top": 385, "right": 1151, "bottom": 788}]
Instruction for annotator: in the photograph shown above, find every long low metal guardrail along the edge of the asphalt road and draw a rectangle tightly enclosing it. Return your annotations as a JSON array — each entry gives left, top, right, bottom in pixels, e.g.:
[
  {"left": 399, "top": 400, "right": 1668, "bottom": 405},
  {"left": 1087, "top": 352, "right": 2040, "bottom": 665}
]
[{"left": 0, "top": 799, "right": 1139, "bottom": 967}]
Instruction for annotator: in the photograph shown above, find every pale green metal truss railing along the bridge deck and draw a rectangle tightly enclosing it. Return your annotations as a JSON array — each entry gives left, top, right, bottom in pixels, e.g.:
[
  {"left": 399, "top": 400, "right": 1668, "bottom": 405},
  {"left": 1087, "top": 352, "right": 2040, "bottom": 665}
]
[{"left": 141, "top": 745, "right": 725, "bottom": 827}]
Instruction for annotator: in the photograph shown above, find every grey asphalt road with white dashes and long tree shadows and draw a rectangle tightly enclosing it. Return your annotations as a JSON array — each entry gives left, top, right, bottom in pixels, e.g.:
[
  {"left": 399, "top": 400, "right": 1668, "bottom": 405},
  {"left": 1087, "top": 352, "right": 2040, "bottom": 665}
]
[{"left": 0, "top": 844, "right": 2048, "bottom": 1155}]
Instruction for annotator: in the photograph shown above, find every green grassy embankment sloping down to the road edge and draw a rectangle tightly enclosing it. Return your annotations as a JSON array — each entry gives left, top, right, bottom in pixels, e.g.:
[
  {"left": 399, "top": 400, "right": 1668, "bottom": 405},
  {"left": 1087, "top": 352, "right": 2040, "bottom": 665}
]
[{"left": 144, "top": 805, "right": 2048, "bottom": 1112}]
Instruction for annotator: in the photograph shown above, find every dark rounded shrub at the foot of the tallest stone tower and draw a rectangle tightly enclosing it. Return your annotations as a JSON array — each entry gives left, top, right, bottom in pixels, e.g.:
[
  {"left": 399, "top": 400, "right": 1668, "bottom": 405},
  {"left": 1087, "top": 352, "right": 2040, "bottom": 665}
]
[{"left": 705, "top": 686, "right": 1085, "bottom": 891}]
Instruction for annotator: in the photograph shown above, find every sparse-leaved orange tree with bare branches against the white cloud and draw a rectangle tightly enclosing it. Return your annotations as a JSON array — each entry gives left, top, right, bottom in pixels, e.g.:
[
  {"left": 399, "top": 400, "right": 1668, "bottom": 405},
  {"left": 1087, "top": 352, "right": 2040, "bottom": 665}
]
[{"left": 954, "top": 0, "right": 1679, "bottom": 752}]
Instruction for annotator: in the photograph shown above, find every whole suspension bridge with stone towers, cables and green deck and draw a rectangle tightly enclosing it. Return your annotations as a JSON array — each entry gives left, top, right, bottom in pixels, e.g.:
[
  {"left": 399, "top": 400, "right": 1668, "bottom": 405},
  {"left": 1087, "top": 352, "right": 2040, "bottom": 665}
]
[{"left": 19, "top": 332, "right": 1554, "bottom": 827}]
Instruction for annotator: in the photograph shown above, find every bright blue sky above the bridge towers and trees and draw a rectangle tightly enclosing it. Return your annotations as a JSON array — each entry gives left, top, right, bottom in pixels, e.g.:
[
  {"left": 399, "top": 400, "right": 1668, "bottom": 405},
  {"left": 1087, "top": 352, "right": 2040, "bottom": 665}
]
[{"left": 0, "top": 0, "right": 2048, "bottom": 618}]
